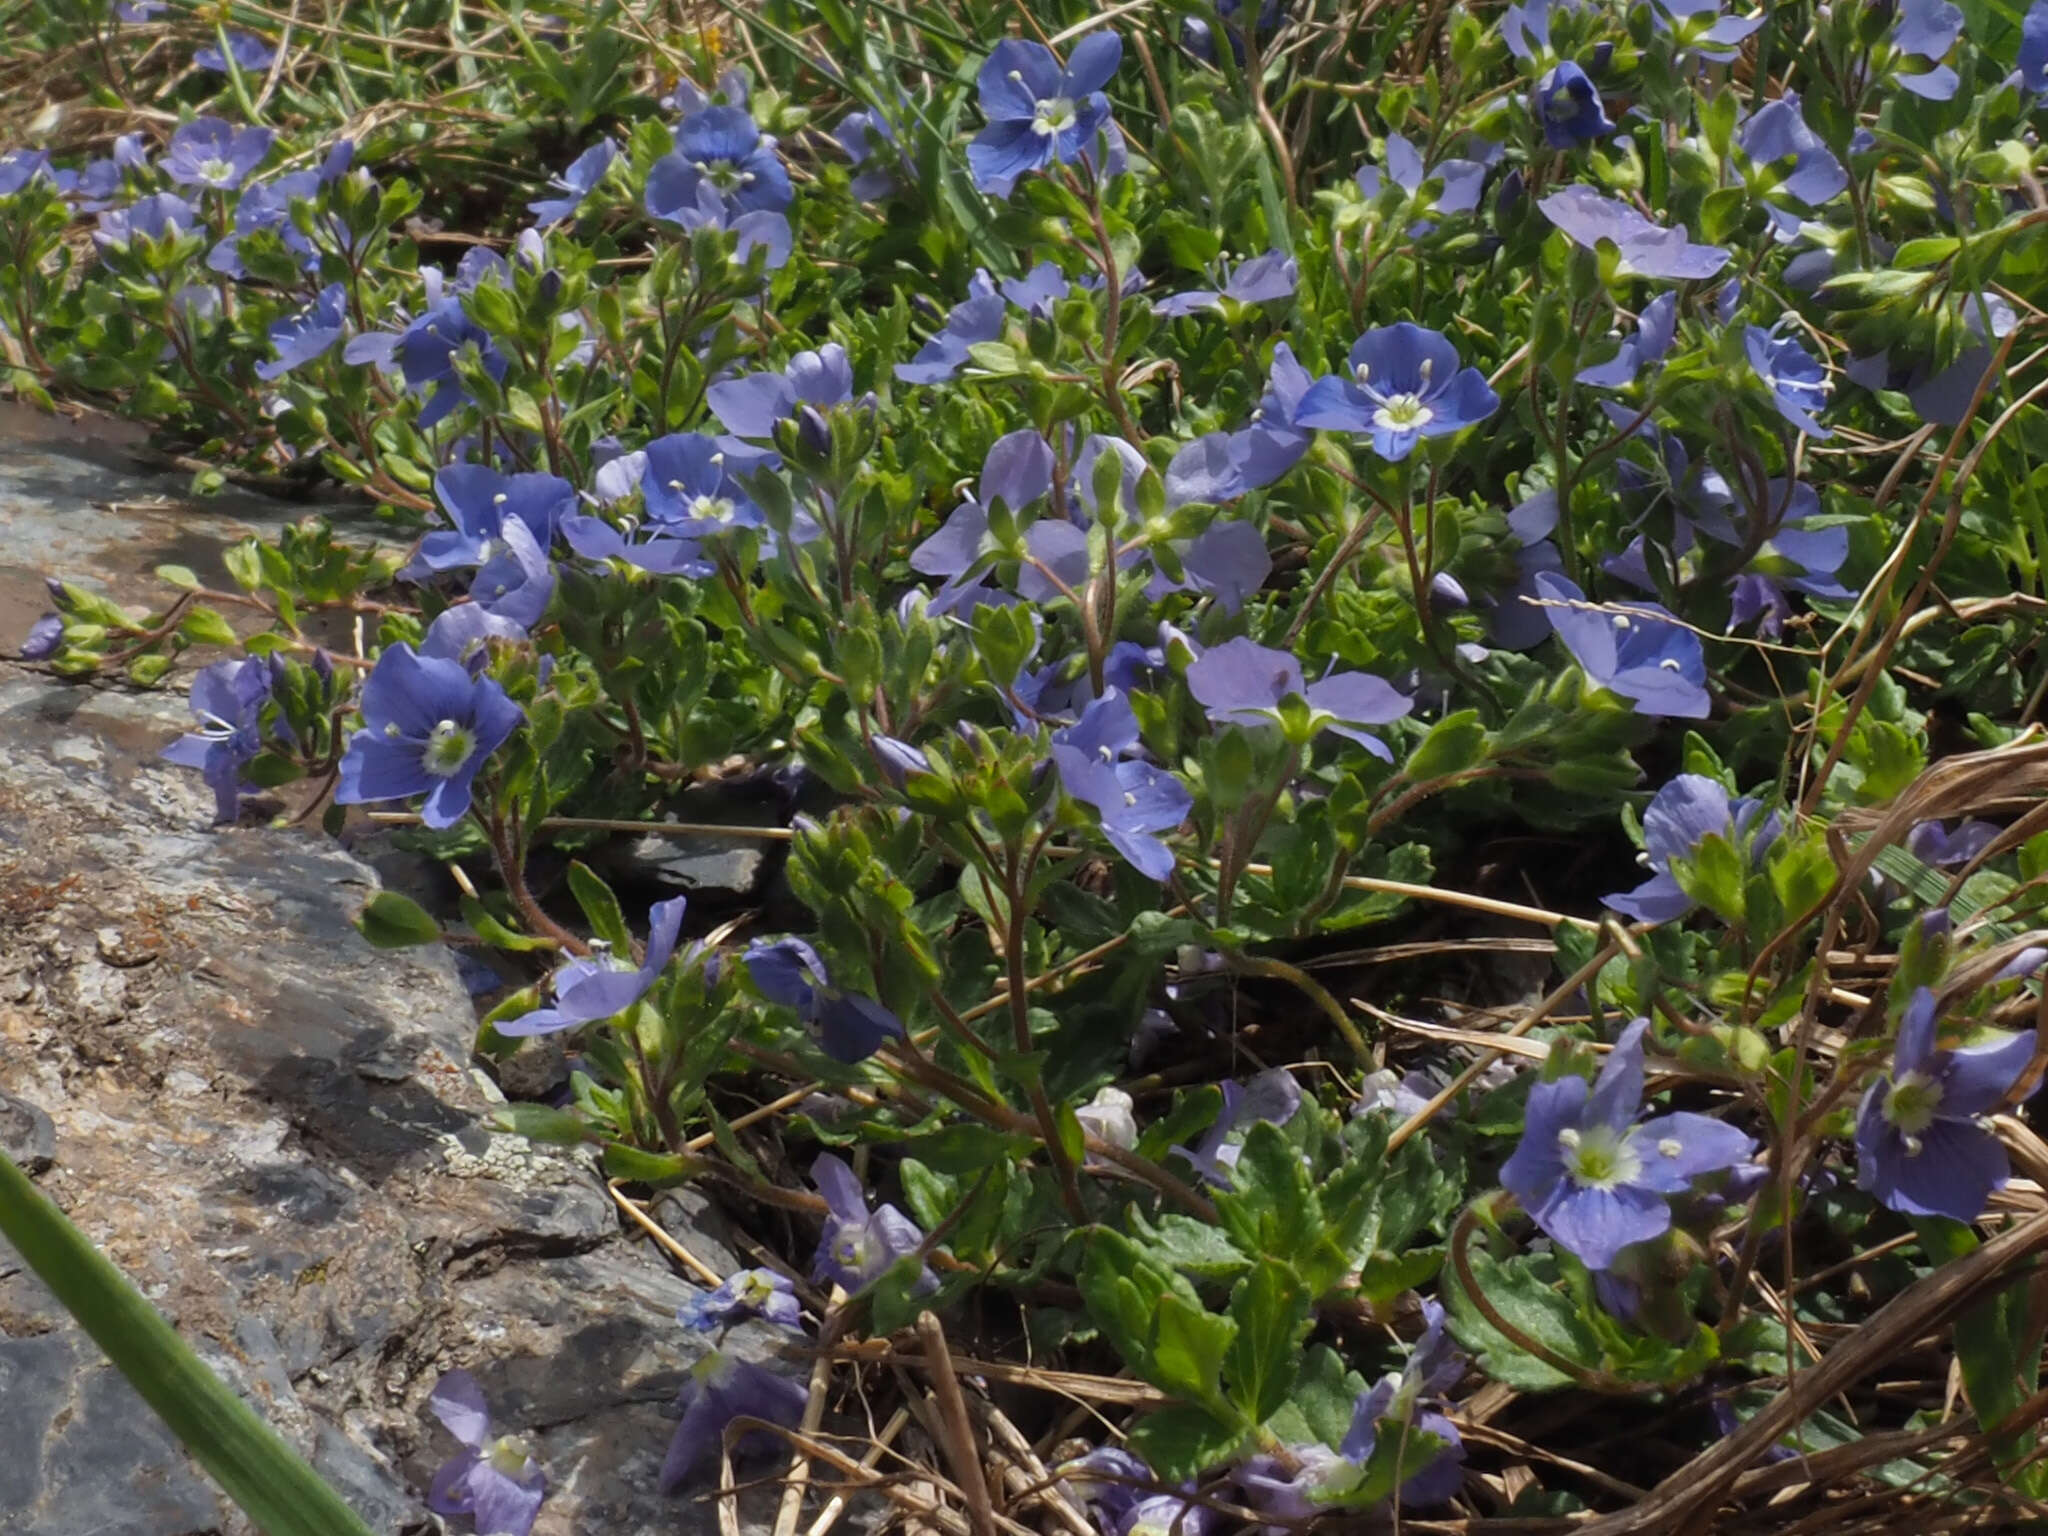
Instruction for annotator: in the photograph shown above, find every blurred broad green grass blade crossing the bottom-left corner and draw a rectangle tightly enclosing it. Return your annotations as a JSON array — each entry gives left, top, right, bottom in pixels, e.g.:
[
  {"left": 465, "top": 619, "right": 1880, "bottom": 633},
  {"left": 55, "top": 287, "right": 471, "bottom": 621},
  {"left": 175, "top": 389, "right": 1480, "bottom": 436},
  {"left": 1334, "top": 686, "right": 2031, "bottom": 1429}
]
[{"left": 0, "top": 1153, "right": 371, "bottom": 1536}]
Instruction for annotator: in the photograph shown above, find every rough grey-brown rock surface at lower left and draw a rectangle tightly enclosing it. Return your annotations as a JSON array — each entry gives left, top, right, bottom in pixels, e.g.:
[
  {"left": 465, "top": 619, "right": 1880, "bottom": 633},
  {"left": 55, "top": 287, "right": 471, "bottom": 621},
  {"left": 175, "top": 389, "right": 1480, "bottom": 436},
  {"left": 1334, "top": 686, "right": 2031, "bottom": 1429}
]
[{"left": 0, "top": 428, "right": 815, "bottom": 1536}]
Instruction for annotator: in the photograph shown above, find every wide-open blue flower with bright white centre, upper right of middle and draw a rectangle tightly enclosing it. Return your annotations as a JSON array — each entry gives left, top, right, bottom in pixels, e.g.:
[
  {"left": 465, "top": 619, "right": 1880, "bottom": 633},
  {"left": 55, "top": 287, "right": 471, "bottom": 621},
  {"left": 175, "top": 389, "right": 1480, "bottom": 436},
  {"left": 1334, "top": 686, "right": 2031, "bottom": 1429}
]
[{"left": 1294, "top": 319, "right": 1501, "bottom": 459}]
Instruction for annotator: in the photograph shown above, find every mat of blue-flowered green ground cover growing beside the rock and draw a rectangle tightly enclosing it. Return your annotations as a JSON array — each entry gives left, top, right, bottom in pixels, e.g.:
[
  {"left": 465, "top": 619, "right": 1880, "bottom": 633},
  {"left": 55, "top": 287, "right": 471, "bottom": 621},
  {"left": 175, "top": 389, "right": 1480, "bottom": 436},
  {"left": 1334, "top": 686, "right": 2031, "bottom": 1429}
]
[{"left": 0, "top": 0, "right": 2048, "bottom": 1536}]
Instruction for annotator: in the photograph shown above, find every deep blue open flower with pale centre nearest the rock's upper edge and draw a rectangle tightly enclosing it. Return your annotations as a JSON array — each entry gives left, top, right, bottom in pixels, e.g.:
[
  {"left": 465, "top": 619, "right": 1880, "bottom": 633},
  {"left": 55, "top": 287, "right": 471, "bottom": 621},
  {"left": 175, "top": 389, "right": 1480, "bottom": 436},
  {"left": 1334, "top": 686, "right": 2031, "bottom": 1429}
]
[{"left": 334, "top": 645, "right": 526, "bottom": 829}]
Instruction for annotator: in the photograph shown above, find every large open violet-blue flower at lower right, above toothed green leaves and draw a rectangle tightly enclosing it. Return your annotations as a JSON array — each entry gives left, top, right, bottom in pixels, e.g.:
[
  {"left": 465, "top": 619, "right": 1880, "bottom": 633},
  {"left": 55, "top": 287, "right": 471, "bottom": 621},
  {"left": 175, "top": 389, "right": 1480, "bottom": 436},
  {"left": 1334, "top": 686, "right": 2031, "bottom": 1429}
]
[{"left": 1501, "top": 1018, "right": 1755, "bottom": 1270}]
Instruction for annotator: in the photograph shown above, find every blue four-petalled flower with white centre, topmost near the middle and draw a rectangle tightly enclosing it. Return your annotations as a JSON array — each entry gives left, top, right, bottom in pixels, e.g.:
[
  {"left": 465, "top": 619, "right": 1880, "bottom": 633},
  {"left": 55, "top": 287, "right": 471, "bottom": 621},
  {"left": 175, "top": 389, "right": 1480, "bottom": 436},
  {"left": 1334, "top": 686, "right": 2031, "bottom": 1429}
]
[{"left": 967, "top": 33, "right": 1124, "bottom": 197}]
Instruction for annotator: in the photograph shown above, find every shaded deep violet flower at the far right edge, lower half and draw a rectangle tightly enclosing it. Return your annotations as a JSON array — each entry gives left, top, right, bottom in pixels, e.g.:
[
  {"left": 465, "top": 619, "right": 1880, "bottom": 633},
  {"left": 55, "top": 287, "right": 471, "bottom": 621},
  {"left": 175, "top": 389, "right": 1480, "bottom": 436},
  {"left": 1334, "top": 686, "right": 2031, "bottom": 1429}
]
[{"left": 1855, "top": 987, "right": 2034, "bottom": 1223}]
